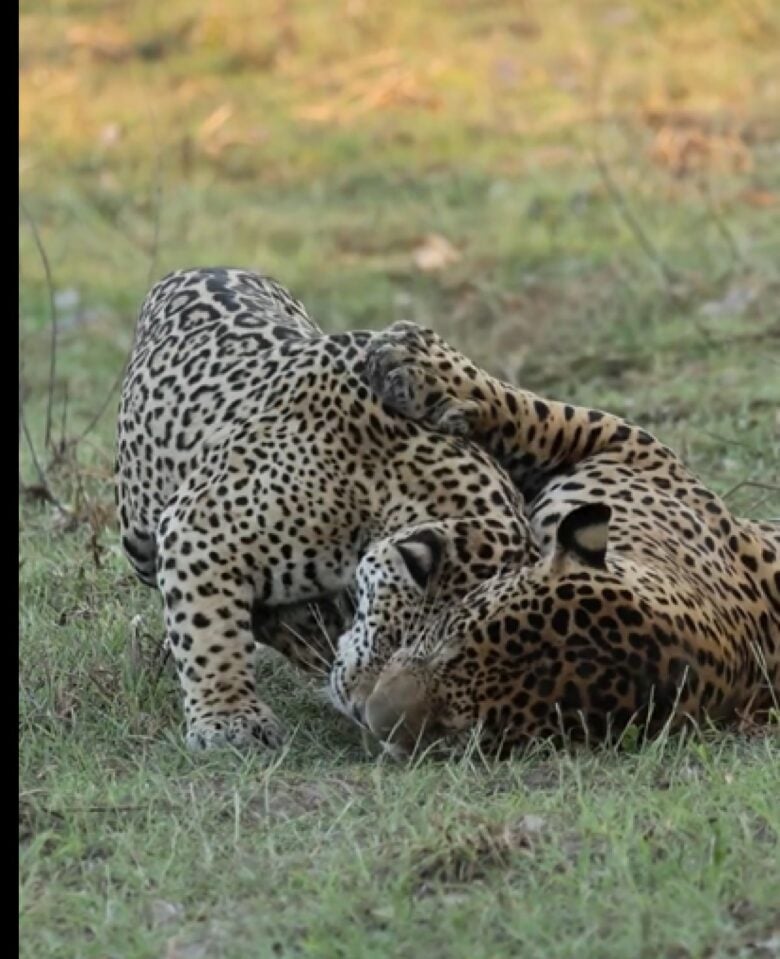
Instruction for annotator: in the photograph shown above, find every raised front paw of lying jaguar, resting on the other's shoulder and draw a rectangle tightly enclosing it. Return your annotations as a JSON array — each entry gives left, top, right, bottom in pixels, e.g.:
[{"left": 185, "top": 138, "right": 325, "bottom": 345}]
[{"left": 366, "top": 322, "right": 479, "bottom": 436}]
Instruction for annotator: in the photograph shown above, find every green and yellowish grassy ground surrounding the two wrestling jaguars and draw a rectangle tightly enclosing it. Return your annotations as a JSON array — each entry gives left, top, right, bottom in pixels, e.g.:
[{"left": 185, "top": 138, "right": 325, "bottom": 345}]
[{"left": 19, "top": 0, "right": 780, "bottom": 959}]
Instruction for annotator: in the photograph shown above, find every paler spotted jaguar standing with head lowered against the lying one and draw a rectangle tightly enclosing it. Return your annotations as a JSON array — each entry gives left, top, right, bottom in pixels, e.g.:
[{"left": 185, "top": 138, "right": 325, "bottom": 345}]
[{"left": 116, "top": 269, "right": 535, "bottom": 748}]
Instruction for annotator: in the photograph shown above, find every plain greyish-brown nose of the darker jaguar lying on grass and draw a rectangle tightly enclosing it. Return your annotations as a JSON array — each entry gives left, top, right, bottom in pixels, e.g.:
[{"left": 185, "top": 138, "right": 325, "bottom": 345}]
[{"left": 366, "top": 668, "right": 431, "bottom": 752}]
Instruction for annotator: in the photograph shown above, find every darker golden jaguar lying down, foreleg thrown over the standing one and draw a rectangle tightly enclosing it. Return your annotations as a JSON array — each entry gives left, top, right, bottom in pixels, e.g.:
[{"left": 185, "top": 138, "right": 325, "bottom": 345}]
[{"left": 330, "top": 323, "right": 780, "bottom": 753}]
